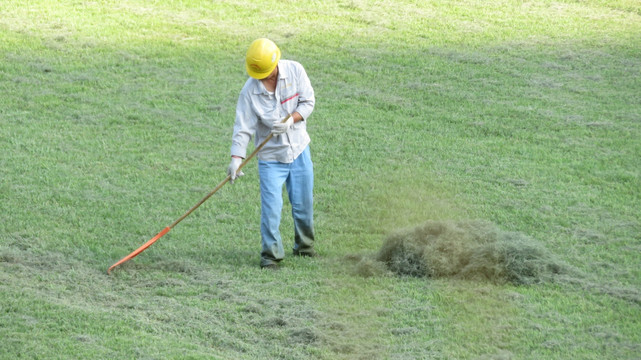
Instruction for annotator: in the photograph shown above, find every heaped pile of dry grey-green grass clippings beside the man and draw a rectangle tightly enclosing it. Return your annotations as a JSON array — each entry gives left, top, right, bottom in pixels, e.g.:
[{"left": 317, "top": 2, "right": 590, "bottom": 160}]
[{"left": 376, "top": 221, "right": 564, "bottom": 284}]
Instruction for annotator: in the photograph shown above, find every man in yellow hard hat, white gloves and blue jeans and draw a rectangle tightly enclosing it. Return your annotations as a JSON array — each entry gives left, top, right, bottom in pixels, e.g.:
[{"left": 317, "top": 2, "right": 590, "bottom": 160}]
[{"left": 227, "top": 38, "right": 316, "bottom": 270}]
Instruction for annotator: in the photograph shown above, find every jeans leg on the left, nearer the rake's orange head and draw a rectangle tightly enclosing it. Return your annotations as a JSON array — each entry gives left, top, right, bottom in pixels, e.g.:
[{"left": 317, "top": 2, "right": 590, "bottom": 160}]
[{"left": 258, "top": 161, "right": 288, "bottom": 266}]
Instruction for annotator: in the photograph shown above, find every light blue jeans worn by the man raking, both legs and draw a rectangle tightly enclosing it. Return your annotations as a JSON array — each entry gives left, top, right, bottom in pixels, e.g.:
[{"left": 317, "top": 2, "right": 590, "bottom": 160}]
[{"left": 258, "top": 146, "right": 314, "bottom": 266}]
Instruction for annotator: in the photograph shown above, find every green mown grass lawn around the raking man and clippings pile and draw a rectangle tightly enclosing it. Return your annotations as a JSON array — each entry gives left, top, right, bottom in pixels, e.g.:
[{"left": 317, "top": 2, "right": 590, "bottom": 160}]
[{"left": 0, "top": 0, "right": 641, "bottom": 359}]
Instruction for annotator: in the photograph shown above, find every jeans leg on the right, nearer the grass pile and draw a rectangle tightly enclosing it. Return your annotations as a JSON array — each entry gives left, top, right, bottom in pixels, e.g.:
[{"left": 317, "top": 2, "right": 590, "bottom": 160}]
[{"left": 286, "top": 147, "right": 314, "bottom": 252}]
